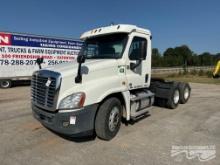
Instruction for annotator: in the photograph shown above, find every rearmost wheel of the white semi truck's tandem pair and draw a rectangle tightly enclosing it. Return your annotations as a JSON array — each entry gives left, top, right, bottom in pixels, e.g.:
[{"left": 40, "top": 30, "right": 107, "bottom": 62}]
[{"left": 179, "top": 83, "right": 191, "bottom": 104}]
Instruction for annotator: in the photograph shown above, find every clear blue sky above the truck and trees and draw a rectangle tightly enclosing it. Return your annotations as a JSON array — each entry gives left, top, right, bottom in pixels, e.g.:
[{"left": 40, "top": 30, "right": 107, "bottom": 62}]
[{"left": 0, "top": 0, "right": 220, "bottom": 54}]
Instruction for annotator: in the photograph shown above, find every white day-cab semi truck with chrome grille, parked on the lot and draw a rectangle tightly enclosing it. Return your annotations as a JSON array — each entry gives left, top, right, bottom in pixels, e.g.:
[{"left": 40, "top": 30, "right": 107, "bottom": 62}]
[{"left": 31, "top": 24, "right": 191, "bottom": 140}]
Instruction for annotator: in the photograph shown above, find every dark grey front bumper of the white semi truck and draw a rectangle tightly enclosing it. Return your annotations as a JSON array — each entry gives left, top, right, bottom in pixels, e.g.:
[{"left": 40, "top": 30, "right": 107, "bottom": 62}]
[{"left": 32, "top": 104, "right": 98, "bottom": 136}]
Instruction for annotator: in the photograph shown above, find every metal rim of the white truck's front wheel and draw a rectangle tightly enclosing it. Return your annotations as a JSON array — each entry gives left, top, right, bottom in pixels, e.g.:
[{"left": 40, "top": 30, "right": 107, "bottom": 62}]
[{"left": 109, "top": 106, "right": 119, "bottom": 132}]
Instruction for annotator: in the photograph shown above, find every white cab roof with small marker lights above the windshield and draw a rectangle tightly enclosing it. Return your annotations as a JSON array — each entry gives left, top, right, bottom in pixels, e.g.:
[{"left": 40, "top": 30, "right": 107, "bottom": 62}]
[{"left": 80, "top": 24, "right": 151, "bottom": 40}]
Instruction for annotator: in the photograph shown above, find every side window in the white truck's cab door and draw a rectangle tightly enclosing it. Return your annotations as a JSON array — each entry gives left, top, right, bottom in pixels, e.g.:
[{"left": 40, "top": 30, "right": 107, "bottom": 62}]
[{"left": 129, "top": 37, "right": 147, "bottom": 60}]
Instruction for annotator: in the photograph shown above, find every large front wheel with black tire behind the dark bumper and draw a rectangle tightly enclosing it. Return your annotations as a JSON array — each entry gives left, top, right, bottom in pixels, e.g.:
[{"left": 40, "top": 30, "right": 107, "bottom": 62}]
[{"left": 95, "top": 97, "right": 122, "bottom": 140}]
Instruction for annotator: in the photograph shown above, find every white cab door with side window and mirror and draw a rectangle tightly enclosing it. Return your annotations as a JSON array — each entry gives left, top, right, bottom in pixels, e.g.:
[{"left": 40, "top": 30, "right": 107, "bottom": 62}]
[{"left": 126, "top": 32, "right": 151, "bottom": 90}]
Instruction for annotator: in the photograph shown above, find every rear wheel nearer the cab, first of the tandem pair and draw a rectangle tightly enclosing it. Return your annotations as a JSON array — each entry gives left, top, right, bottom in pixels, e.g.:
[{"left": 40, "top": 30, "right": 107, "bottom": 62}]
[{"left": 167, "top": 85, "right": 180, "bottom": 109}]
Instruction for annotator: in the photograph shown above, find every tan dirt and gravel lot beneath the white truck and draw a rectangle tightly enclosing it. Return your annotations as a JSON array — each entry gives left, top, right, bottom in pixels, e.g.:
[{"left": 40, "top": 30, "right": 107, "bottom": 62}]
[{"left": 0, "top": 84, "right": 220, "bottom": 165}]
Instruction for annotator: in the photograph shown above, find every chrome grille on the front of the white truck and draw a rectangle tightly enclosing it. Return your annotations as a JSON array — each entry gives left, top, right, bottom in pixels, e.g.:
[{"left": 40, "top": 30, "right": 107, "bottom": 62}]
[{"left": 31, "top": 70, "right": 61, "bottom": 111}]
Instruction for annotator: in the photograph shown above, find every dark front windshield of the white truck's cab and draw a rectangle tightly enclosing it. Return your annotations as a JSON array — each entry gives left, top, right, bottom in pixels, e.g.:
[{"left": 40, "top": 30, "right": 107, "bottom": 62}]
[{"left": 80, "top": 33, "right": 128, "bottom": 59}]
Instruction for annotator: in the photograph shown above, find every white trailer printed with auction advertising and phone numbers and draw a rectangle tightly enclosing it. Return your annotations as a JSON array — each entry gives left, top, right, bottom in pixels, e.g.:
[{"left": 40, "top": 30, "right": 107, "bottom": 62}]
[{"left": 0, "top": 32, "right": 82, "bottom": 88}]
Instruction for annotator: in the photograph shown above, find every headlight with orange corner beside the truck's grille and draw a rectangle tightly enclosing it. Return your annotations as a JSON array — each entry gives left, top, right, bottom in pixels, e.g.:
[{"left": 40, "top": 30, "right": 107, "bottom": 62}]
[{"left": 59, "top": 92, "right": 86, "bottom": 109}]
